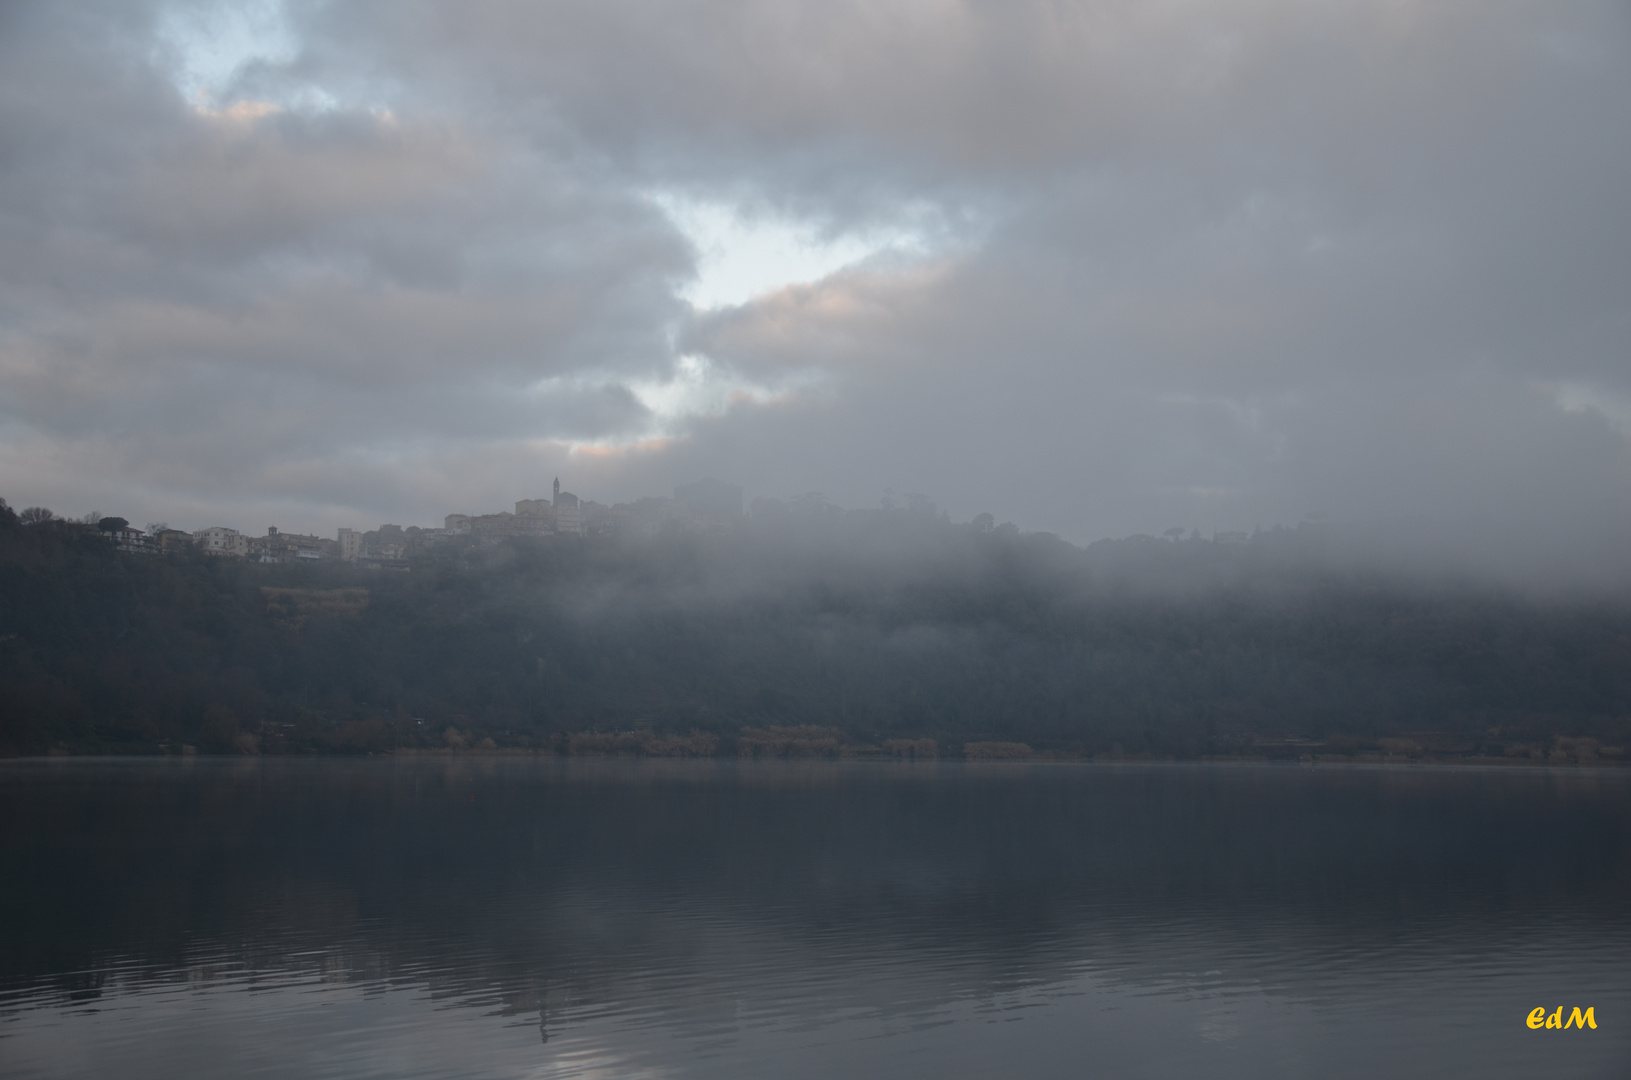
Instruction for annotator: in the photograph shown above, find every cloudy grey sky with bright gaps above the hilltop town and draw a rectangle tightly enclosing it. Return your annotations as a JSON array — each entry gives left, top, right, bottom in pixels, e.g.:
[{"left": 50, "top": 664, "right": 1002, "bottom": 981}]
[{"left": 0, "top": 0, "right": 1631, "bottom": 570}]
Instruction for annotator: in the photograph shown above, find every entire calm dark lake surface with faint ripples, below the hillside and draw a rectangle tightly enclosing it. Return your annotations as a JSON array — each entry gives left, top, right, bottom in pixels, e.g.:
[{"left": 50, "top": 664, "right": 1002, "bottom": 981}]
[{"left": 0, "top": 759, "right": 1631, "bottom": 1078}]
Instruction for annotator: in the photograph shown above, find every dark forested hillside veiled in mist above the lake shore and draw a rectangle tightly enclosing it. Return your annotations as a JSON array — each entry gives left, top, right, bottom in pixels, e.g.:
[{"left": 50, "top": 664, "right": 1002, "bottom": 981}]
[{"left": 0, "top": 502, "right": 1631, "bottom": 762}]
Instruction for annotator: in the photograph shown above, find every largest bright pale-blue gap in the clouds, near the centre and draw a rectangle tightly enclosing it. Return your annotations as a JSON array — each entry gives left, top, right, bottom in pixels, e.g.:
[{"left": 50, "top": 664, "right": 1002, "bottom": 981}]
[{"left": 652, "top": 194, "right": 935, "bottom": 310}]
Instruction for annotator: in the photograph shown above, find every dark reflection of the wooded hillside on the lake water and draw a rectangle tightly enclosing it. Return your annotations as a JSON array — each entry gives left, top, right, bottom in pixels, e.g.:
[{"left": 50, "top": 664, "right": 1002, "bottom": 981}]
[{"left": 0, "top": 759, "right": 1631, "bottom": 1026}]
